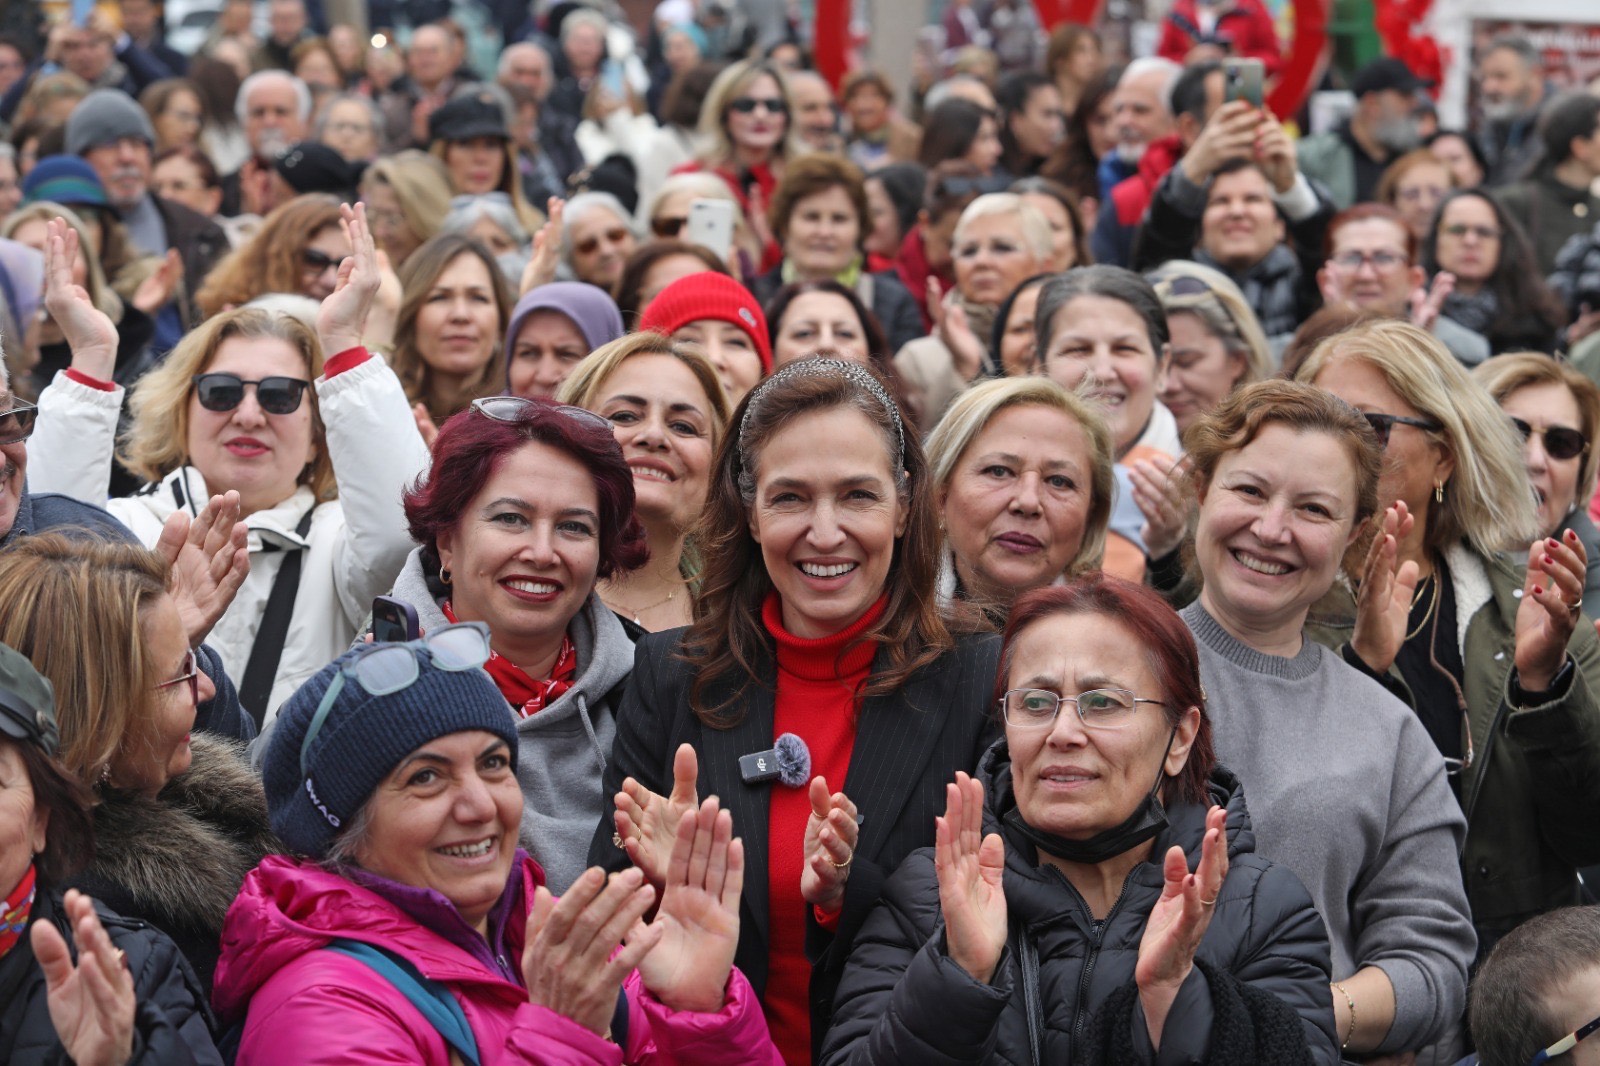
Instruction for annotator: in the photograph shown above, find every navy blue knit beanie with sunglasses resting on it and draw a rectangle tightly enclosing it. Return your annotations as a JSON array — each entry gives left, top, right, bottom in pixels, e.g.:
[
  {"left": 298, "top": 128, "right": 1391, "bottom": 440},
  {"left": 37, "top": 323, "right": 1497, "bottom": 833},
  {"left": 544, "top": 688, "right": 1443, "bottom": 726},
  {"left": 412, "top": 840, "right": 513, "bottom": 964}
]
[{"left": 262, "top": 640, "right": 517, "bottom": 860}]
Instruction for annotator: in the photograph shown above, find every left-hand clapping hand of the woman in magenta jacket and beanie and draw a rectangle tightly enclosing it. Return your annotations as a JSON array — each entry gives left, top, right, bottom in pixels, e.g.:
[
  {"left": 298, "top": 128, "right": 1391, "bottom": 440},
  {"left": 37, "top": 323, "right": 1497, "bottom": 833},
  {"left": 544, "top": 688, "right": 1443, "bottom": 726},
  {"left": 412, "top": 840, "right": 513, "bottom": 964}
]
[{"left": 522, "top": 866, "right": 666, "bottom": 1037}]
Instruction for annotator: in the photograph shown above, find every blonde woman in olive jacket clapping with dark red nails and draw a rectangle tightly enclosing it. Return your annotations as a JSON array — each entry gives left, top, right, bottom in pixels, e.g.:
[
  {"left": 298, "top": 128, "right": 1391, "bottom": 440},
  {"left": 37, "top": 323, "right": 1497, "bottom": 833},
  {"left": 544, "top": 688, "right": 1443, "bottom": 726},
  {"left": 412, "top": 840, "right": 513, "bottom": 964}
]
[{"left": 1298, "top": 322, "right": 1600, "bottom": 951}]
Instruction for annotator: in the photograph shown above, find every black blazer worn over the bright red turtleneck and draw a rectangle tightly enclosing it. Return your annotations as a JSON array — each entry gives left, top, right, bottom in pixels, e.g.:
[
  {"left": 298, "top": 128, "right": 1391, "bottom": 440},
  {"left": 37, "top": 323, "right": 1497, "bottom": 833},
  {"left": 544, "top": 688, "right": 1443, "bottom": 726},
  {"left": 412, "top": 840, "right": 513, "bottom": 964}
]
[{"left": 589, "top": 629, "right": 1000, "bottom": 1055}]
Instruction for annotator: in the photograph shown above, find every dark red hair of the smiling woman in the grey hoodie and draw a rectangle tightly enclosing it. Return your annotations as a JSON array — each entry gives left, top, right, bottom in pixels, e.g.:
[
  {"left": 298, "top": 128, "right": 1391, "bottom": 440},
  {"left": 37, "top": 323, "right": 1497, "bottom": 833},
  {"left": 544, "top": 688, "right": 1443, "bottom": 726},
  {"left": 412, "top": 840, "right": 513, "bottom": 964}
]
[{"left": 403, "top": 399, "right": 650, "bottom": 578}]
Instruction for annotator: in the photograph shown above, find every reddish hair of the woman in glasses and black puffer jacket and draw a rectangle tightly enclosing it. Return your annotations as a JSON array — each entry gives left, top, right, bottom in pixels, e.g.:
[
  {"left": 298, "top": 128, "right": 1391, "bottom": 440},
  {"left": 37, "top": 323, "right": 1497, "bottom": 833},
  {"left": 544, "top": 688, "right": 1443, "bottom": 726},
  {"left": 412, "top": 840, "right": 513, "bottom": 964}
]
[{"left": 992, "top": 570, "right": 1216, "bottom": 804}]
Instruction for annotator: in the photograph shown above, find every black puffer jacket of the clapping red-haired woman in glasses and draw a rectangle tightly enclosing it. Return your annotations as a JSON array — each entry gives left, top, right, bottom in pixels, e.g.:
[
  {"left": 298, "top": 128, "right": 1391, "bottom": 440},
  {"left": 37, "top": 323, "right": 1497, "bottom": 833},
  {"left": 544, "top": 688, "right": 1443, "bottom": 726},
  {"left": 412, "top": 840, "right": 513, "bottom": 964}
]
[{"left": 821, "top": 741, "right": 1339, "bottom": 1066}]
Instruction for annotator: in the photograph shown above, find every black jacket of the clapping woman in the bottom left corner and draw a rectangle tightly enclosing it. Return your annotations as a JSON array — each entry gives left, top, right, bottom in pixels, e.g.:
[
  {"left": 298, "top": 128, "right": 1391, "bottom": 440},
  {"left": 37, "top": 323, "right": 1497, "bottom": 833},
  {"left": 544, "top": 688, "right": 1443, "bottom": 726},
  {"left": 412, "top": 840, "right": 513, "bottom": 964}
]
[{"left": 0, "top": 890, "right": 222, "bottom": 1066}]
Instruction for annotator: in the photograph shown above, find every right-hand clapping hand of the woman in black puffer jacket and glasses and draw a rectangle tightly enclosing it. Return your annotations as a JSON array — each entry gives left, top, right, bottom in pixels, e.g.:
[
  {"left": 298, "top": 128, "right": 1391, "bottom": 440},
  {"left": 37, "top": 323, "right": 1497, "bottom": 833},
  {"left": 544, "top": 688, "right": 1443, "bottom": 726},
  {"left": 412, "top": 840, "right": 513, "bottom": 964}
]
[{"left": 1133, "top": 807, "right": 1227, "bottom": 1048}]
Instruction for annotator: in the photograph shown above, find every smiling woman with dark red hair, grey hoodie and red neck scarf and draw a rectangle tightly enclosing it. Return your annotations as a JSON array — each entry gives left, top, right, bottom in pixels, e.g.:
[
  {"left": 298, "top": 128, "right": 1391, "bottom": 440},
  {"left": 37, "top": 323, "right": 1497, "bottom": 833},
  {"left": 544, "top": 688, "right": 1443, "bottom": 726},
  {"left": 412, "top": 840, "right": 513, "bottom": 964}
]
[{"left": 390, "top": 395, "right": 650, "bottom": 893}]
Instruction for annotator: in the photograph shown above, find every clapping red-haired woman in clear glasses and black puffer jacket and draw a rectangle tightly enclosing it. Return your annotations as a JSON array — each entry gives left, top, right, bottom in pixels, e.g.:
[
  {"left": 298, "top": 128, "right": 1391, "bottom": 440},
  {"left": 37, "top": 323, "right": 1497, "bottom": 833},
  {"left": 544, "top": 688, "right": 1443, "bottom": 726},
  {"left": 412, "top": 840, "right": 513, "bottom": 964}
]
[{"left": 821, "top": 571, "right": 1339, "bottom": 1066}]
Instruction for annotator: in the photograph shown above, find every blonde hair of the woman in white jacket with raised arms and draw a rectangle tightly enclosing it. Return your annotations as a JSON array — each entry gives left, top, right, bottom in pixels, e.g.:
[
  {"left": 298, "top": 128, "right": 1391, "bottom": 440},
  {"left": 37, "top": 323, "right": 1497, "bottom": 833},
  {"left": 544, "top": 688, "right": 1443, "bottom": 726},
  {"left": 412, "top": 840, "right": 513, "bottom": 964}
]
[{"left": 122, "top": 307, "right": 339, "bottom": 499}]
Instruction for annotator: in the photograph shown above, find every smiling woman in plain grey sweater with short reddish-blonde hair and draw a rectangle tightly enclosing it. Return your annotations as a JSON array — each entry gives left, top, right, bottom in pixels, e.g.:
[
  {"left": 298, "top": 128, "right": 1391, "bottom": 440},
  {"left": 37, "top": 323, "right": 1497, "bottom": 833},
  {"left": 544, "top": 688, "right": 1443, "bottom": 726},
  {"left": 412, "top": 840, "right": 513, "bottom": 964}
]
[{"left": 1182, "top": 377, "right": 1475, "bottom": 1061}]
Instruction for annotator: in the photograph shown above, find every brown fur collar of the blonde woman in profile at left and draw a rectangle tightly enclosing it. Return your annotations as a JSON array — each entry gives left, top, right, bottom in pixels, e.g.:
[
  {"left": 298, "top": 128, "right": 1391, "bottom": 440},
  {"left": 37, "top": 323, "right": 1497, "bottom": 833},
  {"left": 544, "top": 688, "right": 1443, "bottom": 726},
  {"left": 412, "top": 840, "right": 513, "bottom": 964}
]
[{"left": 82, "top": 733, "right": 282, "bottom": 932}]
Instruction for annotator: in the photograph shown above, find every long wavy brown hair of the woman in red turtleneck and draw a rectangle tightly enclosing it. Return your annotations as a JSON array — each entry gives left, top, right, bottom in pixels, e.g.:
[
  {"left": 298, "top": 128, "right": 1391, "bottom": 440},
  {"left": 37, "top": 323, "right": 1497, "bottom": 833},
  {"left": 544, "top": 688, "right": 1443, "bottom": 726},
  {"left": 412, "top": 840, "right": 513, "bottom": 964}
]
[{"left": 682, "top": 358, "right": 954, "bottom": 728}]
